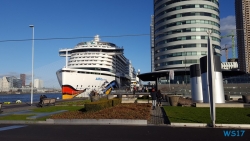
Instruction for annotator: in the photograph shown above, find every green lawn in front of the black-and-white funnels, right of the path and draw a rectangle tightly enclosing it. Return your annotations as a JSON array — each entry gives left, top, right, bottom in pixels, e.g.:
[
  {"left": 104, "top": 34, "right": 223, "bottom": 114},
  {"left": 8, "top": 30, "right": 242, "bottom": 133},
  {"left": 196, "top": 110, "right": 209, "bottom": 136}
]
[{"left": 164, "top": 106, "right": 250, "bottom": 124}]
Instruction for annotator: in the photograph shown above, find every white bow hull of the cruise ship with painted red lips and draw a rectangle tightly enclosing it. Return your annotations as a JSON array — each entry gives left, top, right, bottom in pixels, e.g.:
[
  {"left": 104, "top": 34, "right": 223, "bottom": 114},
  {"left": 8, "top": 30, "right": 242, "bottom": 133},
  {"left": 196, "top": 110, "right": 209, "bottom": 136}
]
[{"left": 57, "top": 68, "right": 115, "bottom": 99}]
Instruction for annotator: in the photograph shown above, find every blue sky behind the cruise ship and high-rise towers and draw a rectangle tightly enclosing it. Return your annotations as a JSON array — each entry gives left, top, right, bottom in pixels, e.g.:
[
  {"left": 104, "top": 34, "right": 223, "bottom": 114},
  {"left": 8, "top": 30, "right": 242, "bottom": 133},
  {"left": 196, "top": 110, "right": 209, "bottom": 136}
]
[{"left": 0, "top": 0, "right": 235, "bottom": 88}]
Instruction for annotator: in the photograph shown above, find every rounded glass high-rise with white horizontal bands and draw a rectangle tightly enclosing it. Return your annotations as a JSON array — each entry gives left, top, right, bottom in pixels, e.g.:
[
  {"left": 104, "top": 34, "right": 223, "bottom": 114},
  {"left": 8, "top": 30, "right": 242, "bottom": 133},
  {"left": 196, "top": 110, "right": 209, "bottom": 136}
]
[{"left": 151, "top": 0, "right": 221, "bottom": 71}]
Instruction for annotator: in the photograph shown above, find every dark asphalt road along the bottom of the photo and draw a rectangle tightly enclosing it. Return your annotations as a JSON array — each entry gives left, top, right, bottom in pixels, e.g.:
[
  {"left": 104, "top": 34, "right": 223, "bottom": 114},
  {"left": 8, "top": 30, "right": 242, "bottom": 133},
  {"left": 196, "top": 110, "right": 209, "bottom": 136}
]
[{"left": 0, "top": 125, "right": 250, "bottom": 141}]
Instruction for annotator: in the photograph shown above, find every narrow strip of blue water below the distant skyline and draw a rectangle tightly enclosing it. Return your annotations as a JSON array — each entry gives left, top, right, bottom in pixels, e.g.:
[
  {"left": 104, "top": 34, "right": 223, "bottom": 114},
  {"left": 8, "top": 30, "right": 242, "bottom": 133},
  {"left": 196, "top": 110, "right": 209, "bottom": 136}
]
[{"left": 0, "top": 93, "right": 62, "bottom": 103}]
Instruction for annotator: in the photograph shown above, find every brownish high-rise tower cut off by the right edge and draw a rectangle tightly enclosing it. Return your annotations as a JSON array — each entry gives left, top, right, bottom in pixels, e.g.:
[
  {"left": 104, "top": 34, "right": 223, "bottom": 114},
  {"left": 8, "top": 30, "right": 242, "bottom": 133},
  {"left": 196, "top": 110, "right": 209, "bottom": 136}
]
[{"left": 235, "top": 0, "right": 250, "bottom": 73}]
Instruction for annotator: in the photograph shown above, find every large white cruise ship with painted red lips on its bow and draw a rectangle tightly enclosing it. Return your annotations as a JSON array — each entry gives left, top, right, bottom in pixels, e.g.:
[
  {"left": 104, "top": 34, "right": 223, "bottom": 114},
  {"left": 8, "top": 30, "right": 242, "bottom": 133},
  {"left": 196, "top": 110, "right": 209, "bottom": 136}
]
[{"left": 56, "top": 35, "right": 135, "bottom": 99}]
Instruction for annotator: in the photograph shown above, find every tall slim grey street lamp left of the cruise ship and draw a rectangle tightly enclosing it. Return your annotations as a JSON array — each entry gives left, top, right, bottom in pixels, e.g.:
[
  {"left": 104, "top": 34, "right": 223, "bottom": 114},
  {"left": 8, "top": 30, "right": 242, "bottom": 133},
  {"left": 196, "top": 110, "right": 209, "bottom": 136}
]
[{"left": 29, "top": 25, "right": 34, "bottom": 106}]
